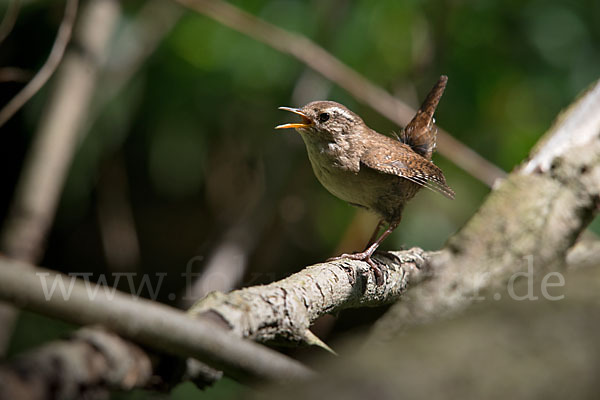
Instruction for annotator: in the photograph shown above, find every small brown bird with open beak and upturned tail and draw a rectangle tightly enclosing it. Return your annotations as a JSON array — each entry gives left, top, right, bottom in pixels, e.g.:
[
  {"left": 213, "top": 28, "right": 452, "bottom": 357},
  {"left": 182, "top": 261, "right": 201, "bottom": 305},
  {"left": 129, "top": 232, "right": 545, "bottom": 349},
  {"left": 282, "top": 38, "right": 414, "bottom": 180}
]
[{"left": 275, "top": 76, "right": 454, "bottom": 284}]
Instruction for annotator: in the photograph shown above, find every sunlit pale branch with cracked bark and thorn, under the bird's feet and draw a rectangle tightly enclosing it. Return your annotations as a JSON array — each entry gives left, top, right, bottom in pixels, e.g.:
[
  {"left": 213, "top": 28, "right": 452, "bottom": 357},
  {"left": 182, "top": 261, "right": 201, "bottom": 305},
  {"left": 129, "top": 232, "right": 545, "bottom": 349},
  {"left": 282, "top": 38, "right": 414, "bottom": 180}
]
[{"left": 189, "top": 248, "right": 430, "bottom": 350}]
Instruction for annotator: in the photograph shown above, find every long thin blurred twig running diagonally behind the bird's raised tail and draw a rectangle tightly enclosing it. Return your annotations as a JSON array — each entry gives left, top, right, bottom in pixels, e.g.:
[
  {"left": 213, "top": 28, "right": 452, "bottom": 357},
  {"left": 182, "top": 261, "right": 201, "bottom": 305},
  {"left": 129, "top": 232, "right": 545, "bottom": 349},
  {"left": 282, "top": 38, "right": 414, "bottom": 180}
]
[{"left": 176, "top": 0, "right": 506, "bottom": 186}]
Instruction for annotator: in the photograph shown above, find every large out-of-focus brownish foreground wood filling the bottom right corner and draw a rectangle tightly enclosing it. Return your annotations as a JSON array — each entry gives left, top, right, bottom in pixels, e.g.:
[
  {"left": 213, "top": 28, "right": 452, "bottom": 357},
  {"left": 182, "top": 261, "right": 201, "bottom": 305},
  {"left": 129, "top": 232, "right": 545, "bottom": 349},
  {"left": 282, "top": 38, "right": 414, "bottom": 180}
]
[{"left": 252, "top": 264, "right": 600, "bottom": 400}]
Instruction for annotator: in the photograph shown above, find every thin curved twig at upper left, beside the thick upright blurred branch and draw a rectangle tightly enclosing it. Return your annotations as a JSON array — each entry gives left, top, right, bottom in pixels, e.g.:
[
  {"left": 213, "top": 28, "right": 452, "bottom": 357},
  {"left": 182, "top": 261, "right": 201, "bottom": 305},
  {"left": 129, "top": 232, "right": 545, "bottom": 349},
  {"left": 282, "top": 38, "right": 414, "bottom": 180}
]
[{"left": 0, "top": 0, "right": 78, "bottom": 127}]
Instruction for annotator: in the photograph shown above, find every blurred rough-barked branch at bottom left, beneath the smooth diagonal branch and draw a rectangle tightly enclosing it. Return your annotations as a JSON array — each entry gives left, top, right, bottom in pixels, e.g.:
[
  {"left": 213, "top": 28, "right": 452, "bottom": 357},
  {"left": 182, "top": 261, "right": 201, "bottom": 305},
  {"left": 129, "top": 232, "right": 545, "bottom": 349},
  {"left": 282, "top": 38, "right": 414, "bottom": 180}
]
[{"left": 0, "top": 328, "right": 152, "bottom": 399}]
